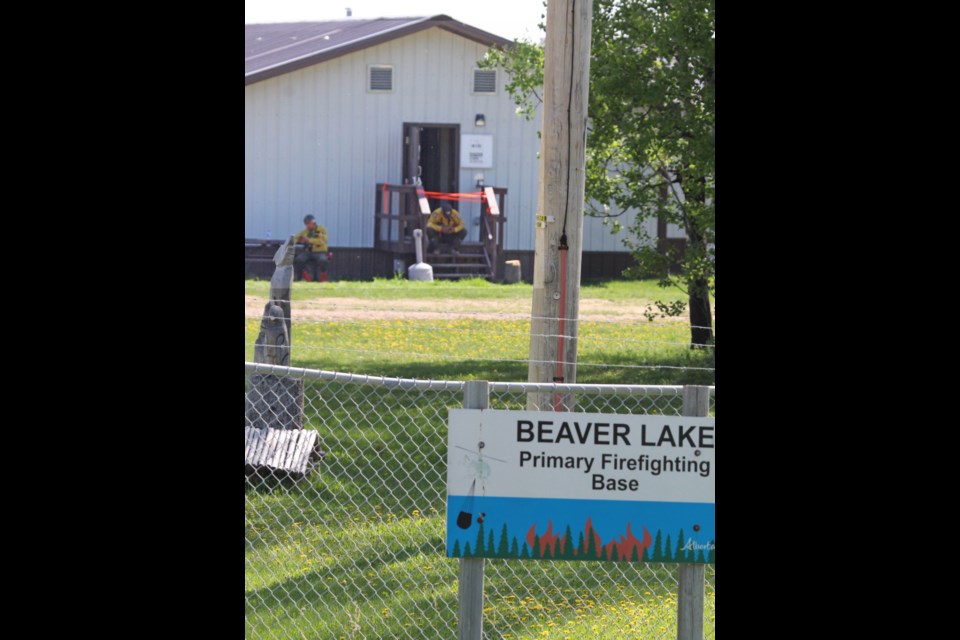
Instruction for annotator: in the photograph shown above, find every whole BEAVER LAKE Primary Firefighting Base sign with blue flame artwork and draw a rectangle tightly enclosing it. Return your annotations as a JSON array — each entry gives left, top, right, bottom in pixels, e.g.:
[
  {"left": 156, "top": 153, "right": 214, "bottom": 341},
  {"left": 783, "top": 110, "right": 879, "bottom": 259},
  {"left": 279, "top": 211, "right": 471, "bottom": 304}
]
[{"left": 447, "top": 409, "right": 716, "bottom": 563}]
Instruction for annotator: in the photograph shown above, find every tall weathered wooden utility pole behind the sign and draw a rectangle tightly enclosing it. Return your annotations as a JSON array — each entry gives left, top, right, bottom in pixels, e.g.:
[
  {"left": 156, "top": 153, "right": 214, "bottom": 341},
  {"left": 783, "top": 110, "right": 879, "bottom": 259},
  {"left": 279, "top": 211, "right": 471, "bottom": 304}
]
[{"left": 527, "top": 0, "right": 592, "bottom": 410}]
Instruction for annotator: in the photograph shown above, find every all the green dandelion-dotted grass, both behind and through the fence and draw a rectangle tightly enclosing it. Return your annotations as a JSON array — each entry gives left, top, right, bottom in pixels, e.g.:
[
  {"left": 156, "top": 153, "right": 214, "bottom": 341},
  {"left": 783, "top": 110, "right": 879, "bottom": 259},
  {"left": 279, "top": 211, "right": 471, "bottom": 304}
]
[{"left": 244, "top": 281, "right": 715, "bottom": 640}]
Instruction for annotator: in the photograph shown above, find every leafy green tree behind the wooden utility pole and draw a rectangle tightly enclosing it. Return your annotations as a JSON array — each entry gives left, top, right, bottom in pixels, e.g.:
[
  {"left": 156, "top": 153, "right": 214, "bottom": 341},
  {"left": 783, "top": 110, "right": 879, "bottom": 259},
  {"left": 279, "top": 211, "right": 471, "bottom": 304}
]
[{"left": 479, "top": 0, "right": 716, "bottom": 347}]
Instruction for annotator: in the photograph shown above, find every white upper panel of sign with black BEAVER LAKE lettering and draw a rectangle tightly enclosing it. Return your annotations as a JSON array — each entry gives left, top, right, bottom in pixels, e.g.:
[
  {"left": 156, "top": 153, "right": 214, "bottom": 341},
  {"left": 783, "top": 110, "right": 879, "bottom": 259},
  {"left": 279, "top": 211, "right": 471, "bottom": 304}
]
[{"left": 447, "top": 409, "right": 716, "bottom": 503}]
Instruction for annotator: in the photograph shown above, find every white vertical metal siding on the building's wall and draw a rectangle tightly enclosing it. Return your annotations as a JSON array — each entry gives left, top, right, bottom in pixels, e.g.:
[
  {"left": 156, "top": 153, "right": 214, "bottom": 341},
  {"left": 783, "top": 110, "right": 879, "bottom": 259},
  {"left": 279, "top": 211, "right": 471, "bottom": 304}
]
[{"left": 244, "top": 28, "right": 655, "bottom": 252}]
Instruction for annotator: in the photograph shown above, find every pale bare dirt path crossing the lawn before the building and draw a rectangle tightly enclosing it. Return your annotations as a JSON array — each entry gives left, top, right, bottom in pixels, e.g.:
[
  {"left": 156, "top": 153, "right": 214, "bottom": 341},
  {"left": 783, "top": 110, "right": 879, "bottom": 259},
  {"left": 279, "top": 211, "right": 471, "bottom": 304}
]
[{"left": 244, "top": 296, "right": 672, "bottom": 322}]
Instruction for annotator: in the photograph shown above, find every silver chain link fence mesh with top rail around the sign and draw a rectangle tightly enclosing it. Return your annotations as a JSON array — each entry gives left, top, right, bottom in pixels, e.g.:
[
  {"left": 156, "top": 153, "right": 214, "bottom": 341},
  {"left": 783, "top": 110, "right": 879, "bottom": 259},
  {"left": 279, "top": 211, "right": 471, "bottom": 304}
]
[{"left": 245, "top": 363, "right": 716, "bottom": 640}]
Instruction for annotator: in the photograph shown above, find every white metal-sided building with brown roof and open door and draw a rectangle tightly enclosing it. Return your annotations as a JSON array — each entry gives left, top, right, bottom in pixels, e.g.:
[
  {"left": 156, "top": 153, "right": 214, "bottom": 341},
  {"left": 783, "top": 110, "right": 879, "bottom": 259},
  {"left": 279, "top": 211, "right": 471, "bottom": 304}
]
[{"left": 244, "top": 15, "right": 655, "bottom": 275}]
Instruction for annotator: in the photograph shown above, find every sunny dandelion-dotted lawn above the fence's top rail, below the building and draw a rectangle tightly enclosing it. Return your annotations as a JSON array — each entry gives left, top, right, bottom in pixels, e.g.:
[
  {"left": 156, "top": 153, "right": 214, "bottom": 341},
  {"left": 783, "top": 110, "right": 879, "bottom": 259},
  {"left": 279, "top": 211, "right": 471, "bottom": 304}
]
[{"left": 244, "top": 280, "right": 714, "bottom": 384}]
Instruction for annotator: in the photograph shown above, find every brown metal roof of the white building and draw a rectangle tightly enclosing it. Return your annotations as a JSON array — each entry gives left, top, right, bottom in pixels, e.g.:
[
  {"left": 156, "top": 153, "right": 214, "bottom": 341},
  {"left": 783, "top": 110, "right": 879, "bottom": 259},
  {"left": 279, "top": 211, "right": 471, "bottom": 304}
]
[{"left": 243, "top": 15, "right": 510, "bottom": 84}]
